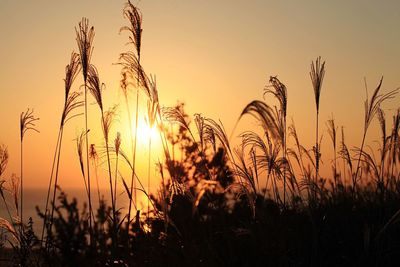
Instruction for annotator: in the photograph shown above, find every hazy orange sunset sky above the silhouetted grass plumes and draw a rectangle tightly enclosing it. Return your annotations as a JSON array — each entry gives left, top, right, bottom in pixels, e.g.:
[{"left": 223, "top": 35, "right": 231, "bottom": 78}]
[{"left": 0, "top": 0, "right": 400, "bottom": 193}]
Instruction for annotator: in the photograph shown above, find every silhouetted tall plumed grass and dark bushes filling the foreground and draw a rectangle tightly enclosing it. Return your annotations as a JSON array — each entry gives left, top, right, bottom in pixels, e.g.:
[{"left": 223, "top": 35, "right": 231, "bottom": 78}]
[{"left": 0, "top": 1, "right": 400, "bottom": 266}]
